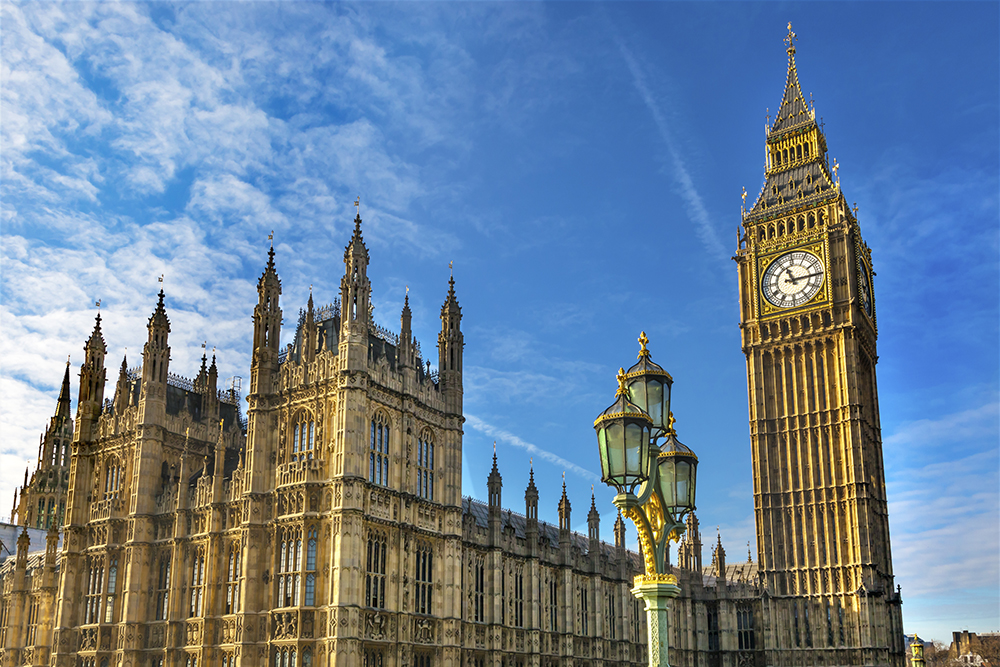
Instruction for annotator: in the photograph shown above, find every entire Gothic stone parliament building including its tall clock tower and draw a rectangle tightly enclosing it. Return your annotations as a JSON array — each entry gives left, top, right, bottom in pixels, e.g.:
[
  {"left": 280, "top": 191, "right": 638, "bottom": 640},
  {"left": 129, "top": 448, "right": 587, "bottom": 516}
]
[{"left": 0, "top": 26, "right": 904, "bottom": 667}]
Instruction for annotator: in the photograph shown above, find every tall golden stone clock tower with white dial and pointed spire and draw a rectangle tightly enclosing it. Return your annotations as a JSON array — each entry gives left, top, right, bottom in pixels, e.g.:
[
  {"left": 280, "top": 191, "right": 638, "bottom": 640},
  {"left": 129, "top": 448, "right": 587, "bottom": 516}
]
[{"left": 735, "top": 24, "right": 904, "bottom": 666}]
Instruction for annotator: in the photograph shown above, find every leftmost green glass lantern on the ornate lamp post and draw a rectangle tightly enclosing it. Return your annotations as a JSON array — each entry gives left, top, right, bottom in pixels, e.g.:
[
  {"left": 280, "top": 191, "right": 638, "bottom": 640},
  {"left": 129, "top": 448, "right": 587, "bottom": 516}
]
[{"left": 594, "top": 369, "right": 653, "bottom": 493}]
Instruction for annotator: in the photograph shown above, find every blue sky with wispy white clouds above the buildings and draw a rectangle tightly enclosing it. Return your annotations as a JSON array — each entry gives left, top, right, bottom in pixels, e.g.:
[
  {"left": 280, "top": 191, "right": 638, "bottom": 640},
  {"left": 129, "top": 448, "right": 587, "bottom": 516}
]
[{"left": 0, "top": 2, "right": 1000, "bottom": 639}]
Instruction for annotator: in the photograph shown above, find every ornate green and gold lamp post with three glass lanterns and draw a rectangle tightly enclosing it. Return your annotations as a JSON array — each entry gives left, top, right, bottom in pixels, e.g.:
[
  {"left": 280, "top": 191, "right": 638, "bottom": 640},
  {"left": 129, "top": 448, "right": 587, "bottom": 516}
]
[{"left": 594, "top": 332, "right": 698, "bottom": 667}]
